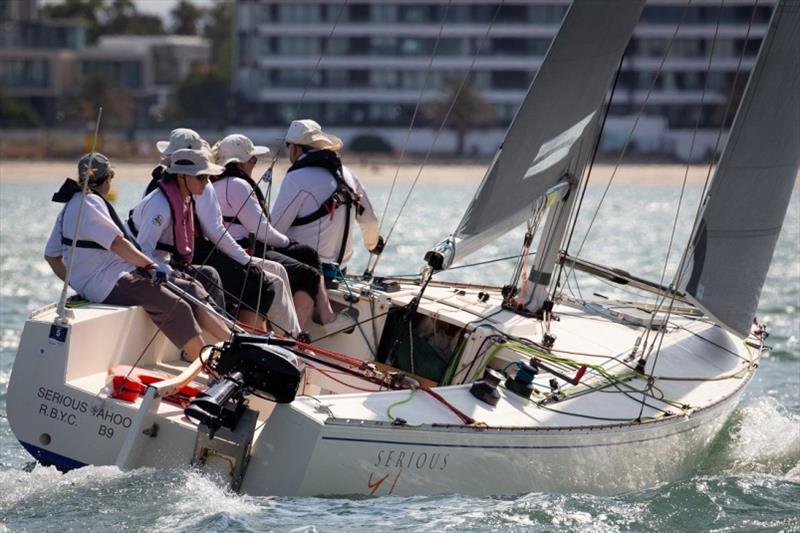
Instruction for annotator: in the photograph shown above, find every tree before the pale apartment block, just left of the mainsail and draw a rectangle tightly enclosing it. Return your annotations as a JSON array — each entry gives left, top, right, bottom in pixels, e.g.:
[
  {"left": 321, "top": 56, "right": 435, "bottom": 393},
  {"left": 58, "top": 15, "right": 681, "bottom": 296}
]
[{"left": 427, "top": 80, "right": 494, "bottom": 156}]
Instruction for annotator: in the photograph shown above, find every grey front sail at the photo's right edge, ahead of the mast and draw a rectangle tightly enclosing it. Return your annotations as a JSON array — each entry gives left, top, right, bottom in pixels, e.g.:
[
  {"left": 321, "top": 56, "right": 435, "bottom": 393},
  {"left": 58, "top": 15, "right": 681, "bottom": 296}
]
[{"left": 683, "top": 0, "right": 800, "bottom": 337}]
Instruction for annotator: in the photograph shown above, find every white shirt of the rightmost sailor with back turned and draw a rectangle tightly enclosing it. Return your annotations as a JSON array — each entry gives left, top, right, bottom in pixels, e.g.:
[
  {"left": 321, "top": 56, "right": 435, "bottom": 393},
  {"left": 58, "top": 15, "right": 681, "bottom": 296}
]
[{"left": 272, "top": 156, "right": 378, "bottom": 266}]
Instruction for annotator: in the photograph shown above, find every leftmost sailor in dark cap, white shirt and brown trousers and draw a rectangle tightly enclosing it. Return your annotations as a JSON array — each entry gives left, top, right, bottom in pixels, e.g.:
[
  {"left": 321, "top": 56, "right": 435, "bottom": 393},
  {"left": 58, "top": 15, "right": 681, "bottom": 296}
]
[{"left": 44, "top": 153, "right": 231, "bottom": 359}]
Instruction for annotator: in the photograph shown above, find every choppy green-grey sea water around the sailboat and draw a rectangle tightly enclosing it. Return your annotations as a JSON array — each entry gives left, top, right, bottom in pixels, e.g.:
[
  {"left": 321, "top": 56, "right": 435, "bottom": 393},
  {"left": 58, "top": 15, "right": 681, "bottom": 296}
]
[{"left": 0, "top": 182, "right": 800, "bottom": 532}]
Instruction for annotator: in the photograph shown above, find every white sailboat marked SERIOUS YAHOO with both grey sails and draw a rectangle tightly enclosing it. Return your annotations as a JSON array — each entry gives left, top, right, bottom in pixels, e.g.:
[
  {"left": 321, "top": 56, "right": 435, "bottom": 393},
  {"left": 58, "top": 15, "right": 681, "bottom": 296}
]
[{"left": 7, "top": 0, "right": 800, "bottom": 496}]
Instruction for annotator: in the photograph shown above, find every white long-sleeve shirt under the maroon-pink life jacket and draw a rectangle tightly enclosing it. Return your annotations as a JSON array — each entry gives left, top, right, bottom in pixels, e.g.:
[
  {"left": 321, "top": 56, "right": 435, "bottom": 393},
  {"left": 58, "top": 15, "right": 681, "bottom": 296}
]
[{"left": 132, "top": 185, "right": 250, "bottom": 265}]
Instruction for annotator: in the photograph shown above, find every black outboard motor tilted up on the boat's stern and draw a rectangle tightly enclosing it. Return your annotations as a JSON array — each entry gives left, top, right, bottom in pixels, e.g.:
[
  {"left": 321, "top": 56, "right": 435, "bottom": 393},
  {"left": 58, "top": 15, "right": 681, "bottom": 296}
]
[{"left": 184, "top": 334, "right": 305, "bottom": 435}]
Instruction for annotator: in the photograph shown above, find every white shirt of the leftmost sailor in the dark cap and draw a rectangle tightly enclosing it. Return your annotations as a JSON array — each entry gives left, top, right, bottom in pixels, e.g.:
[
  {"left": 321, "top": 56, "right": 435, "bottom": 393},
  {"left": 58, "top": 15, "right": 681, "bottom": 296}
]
[{"left": 44, "top": 193, "right": 136, "bottom": 302}]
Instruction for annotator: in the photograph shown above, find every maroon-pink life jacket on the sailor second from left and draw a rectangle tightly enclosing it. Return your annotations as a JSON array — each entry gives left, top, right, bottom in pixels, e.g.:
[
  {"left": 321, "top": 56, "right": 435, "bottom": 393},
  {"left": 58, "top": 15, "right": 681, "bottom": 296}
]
[{"left": 128, "top": 175, "right": 198, "bottom": 263}]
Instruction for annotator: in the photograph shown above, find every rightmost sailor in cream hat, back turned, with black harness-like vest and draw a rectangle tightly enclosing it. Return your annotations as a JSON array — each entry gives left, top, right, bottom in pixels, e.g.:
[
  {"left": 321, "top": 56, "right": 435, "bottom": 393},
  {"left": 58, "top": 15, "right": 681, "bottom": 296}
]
[{"left": 272, "top": 119, "right": 384, "bottom": 270}]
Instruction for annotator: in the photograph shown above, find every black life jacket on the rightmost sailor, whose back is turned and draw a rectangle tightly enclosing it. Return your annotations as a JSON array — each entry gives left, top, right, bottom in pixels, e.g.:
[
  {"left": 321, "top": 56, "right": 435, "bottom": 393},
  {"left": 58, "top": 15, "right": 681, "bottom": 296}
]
[{"left": 287, "top": 150, "right": 364, "bottom": 264}]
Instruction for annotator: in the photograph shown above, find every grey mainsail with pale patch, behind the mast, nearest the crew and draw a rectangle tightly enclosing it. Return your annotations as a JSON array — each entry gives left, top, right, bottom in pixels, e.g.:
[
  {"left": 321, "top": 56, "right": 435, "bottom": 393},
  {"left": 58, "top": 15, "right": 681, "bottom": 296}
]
[{"left": 444, "top": 0, "right": 644, "bottom": 267}]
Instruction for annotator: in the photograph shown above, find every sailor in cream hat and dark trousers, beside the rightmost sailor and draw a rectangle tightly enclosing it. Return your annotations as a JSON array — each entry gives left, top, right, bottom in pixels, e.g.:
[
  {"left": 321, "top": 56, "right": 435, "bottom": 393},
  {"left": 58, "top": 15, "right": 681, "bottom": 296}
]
[{"left": 211, "top": 134, "right": 336, "bottom": 327}]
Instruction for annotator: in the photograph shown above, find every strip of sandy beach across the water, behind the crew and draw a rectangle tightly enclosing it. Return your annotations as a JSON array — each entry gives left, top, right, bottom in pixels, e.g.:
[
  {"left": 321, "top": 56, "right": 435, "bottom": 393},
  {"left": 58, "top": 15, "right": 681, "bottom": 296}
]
[{"left": 0, "top": 157, "right": 724, "bottom": 186}]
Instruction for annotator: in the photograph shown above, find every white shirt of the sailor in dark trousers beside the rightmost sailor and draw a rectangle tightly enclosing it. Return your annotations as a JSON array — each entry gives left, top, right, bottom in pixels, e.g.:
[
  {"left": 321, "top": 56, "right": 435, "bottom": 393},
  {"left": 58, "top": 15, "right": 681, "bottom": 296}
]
[{"left": 213, "top": 177, "right": 289, "bottom": 248}]
